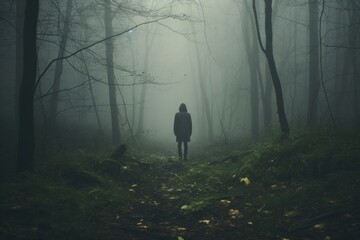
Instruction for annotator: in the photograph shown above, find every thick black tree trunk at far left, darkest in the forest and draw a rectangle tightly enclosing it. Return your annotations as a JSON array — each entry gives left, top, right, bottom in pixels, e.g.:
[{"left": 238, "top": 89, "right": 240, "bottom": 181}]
[{"left": 17, "top": 0, "right": 39, "bottom": 172}]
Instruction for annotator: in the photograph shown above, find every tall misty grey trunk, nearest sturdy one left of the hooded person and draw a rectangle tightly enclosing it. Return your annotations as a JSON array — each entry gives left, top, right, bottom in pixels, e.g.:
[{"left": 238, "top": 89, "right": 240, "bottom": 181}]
[{"left": 104, "top": 0, "right": 121, "bottom": 144}]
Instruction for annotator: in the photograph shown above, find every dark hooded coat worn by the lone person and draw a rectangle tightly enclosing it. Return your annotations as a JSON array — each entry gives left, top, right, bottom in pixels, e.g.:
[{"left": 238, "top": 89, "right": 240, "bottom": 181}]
[{"left": 174, "top": 103, "right": 192, "bottom": 142}]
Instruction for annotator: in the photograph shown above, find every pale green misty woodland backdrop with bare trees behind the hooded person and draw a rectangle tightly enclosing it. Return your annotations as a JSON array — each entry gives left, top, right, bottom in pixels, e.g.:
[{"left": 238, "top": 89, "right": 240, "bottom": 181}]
[{"left": 0, "top": 0, "right": 360, "bottom": 170}]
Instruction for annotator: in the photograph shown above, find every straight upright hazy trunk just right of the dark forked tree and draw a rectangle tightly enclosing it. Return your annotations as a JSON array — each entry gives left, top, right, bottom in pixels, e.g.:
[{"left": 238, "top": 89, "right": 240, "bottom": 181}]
[{"left": 307, "top": 0, "right": 320, "bottom": 126}]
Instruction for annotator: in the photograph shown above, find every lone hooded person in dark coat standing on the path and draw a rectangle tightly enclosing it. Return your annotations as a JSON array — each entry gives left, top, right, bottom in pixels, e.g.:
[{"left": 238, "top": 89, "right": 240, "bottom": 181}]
[{"left": 174, "top": 103, "right": 192, "bottom": 161}]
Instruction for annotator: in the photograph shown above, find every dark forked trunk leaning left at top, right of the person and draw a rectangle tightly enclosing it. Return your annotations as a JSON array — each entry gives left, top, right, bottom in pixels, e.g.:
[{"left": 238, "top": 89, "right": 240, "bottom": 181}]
[{"left": 253, "top": 0, "right": 290, "bottom": 137}]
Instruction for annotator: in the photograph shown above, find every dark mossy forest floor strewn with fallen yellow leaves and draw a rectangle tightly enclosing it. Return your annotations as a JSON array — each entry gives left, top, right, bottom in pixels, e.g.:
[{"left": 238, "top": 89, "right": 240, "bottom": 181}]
[{"left": 0, "top": 132, "right": 360, "bottom": 240}]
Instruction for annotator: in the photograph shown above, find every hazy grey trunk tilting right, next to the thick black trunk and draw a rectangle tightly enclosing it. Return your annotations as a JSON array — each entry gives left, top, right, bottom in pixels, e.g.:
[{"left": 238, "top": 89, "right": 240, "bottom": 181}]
[{"left": 49, "top": 0, "right": 72, "bottom": 134}]
